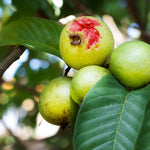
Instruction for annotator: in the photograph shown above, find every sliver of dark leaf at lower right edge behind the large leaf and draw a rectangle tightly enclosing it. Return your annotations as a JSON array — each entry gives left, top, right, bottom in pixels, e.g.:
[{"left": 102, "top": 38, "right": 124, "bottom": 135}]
[{"left": 135, "top": 102, "right": 150, "bottom": 150}]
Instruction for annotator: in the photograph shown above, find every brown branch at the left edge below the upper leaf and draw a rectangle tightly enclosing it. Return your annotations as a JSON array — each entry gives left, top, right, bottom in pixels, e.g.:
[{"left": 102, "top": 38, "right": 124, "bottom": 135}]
[{"left": 0, "top": 46, "right": 26, "bottom": 78}]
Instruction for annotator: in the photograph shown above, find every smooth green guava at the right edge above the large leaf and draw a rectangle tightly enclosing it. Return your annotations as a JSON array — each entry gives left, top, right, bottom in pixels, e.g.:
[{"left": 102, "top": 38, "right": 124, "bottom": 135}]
[{"left": 109, "top": 41, "right": 150, "bottom": 88}]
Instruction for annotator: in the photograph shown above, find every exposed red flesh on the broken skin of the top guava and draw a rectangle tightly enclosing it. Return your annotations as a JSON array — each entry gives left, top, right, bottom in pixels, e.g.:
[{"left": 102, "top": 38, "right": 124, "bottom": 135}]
[{"left": 69, "top": 18, "right": 101, "bottom": 50}]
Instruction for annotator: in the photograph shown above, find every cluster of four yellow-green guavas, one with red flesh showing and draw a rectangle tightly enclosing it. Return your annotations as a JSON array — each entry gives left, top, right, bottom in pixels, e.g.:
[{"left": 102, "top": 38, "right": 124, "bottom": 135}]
[{"left": 39, "top": 16, "right": 150, "bottom": 125}]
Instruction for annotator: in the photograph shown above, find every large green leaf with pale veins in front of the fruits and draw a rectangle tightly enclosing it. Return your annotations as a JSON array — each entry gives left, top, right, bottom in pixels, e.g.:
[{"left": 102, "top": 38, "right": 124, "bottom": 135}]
[{"left": 73, "top": 75, "right": 150, "bottom": 150}]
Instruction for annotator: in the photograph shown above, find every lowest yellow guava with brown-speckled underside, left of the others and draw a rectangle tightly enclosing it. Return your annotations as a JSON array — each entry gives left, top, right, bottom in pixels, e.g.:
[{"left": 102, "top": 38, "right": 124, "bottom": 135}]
[{"left": 39, "top": 77, "right": 72, "bottom": 125}]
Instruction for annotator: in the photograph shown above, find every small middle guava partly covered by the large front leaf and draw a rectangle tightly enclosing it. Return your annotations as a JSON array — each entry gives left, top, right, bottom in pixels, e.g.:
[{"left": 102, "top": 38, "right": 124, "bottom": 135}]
[{"left": 71, "top": 65, "right": 110, "bottom": 104}]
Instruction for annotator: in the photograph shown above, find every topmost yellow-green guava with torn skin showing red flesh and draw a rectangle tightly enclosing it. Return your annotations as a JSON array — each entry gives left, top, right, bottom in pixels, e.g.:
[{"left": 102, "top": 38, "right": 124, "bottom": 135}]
[{"left": 59, "top": 16, "right": 114, "bottom": 70}]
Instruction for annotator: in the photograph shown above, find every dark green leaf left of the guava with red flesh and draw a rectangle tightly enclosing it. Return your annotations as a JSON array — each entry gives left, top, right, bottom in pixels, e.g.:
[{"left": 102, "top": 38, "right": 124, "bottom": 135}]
[{"left": 0, "top": 17, "right": 63, "bottom": 57}]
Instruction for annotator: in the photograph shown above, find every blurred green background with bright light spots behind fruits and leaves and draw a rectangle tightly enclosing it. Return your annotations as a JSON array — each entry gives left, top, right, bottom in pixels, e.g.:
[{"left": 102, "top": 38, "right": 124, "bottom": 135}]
[{"left": 0, "top": 0, "right": 150, "bottom": 150}]
